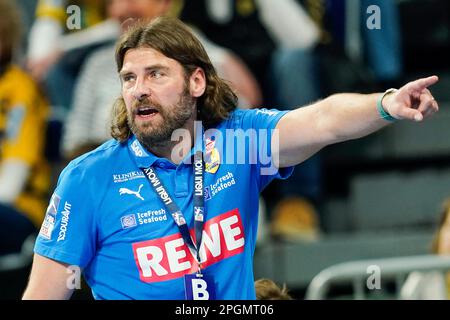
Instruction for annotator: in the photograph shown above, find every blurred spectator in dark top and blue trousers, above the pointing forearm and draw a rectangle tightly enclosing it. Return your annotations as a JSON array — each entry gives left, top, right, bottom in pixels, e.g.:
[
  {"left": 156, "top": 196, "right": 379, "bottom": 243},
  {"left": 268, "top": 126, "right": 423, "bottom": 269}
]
[{"left": 298, "top": 0, "right": 403, "bottom": 95}]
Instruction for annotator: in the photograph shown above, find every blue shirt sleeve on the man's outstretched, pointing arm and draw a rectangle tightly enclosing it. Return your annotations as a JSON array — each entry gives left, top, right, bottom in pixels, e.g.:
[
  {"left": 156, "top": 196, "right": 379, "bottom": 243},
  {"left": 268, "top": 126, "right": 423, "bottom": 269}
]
[{"left": 236, "top": 108, "right": 294, "bottom": 191}]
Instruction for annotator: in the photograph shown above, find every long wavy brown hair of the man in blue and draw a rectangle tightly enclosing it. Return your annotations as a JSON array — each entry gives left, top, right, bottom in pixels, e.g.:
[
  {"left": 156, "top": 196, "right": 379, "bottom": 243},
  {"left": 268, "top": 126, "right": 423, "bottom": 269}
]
[{"left": 111, "top": 17, "right": 237, "bottom": 142}]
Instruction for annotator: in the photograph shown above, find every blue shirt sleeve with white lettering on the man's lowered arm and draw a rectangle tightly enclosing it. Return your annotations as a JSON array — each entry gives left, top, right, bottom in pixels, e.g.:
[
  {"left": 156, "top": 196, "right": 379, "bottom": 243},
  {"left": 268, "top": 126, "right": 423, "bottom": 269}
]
[{"left": 34, "top": 165, "right": 97, "bottom": 268}]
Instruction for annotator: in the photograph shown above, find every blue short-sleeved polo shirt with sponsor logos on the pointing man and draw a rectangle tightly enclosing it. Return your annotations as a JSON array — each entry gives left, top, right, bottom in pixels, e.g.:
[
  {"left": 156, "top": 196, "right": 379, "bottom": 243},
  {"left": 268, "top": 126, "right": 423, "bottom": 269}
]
[{"left": 35, "top": 109, "right": 293, "bottom": 299}]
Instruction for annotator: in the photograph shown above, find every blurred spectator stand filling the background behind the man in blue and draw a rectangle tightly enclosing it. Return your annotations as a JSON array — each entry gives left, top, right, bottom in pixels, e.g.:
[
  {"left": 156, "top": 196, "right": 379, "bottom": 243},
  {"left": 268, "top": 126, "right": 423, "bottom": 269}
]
[{"left": 0, "top": 0, "right": 450, "bottom": 299}]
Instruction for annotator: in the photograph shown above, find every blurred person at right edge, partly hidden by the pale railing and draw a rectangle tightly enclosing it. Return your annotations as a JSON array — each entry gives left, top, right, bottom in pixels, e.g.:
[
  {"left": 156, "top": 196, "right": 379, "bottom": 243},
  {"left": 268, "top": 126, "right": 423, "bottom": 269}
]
[{"left": 401, "top": 199, "right": 450, "bottom": 300}]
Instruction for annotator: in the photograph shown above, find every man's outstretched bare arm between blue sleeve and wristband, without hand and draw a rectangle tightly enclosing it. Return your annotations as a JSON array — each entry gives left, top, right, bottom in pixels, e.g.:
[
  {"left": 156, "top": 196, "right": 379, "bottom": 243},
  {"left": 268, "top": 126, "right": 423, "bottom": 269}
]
[{"left": 275, "top": 93, "right": 396, "bottom": 167}]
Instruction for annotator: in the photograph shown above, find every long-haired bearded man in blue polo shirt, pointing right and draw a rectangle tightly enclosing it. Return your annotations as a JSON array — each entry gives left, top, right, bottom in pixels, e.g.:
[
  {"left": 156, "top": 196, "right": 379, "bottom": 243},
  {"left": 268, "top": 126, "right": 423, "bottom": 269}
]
[{"left": 24, "top": 18, "right": 438, "bottom": 299}]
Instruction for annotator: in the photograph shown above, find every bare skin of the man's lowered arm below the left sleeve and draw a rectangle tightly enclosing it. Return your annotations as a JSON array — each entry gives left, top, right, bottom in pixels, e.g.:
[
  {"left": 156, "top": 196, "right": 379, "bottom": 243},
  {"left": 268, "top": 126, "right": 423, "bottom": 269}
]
[{"left": 22, "top": 254, "right": 73, "bottom": 300}]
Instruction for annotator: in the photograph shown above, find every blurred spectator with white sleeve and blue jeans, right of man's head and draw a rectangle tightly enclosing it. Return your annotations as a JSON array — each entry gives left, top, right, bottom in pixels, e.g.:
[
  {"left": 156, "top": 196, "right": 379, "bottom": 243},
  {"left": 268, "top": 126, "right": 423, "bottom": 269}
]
[{"left": 181, "top": 0, "right": 318, "bottom": 108}]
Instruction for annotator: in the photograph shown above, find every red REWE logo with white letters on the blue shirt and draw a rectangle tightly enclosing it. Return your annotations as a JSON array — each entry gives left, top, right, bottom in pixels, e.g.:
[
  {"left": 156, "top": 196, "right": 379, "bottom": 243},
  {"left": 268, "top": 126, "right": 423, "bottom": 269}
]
[{"left": 133, "top": 209, "right": 245, "bottom": 282}]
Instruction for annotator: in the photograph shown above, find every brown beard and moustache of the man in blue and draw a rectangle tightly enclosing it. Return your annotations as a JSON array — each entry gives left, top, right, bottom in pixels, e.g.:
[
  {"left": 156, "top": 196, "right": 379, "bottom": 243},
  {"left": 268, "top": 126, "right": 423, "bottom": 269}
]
[{"left": 127, "top": 85, "right": 195, "bottom": 149}]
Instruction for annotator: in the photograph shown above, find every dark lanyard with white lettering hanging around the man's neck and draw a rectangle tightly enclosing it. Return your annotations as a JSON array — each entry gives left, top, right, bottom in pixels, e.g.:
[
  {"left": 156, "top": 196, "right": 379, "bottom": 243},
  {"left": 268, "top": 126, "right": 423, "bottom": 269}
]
[{"left": 141, "top": 150, "right": 205, "bottom": 273}]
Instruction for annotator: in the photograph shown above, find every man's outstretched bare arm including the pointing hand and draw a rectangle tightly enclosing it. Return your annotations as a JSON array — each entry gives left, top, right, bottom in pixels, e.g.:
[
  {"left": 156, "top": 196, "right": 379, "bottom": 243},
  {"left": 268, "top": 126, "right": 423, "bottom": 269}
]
[{"left": 272, "top": 76, "right": 438, "bottom": 167}]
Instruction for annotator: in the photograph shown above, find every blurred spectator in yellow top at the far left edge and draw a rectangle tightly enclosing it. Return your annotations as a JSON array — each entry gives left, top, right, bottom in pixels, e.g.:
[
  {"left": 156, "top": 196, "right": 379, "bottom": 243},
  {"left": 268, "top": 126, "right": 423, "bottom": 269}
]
[{"left": 0, "top": 0, "right": 50, "bottom": 255}]
